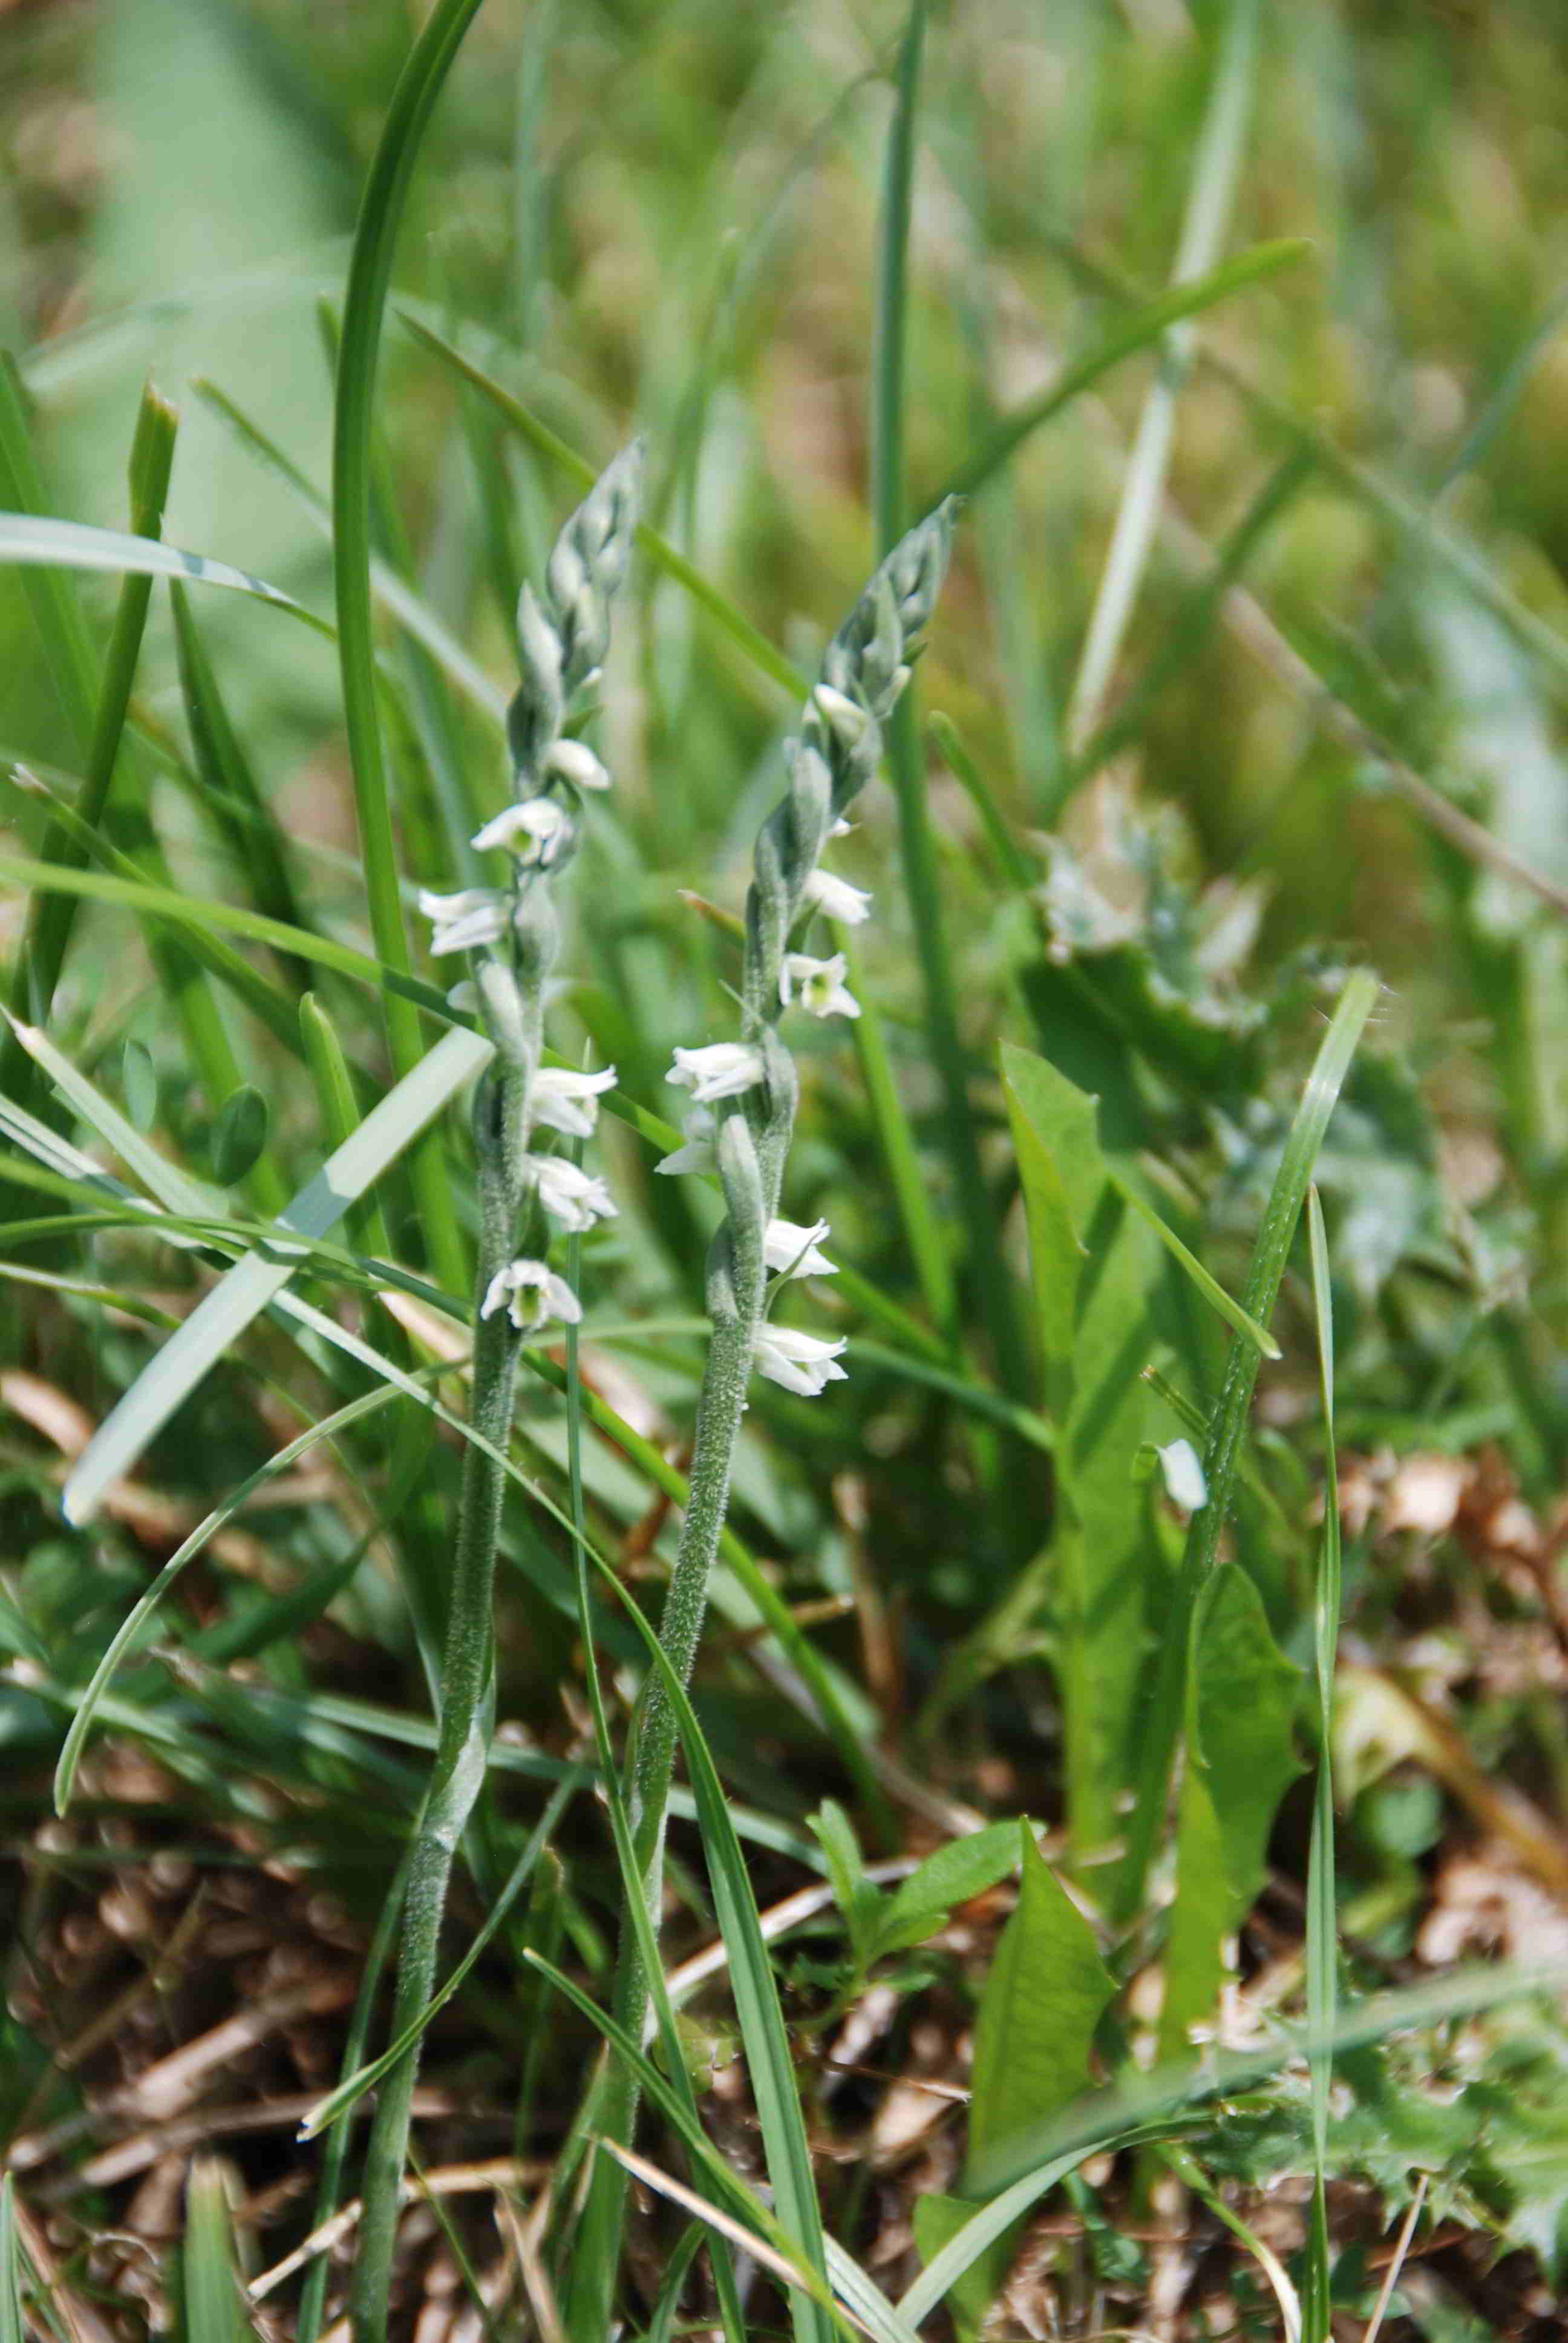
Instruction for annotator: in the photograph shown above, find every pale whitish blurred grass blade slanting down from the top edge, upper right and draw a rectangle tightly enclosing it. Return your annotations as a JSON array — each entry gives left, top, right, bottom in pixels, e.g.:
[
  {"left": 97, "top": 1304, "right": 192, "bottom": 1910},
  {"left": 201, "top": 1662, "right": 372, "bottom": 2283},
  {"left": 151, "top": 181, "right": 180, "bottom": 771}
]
[{"left": 1067, "top": 0, "right": 1259, "bottom": 757}]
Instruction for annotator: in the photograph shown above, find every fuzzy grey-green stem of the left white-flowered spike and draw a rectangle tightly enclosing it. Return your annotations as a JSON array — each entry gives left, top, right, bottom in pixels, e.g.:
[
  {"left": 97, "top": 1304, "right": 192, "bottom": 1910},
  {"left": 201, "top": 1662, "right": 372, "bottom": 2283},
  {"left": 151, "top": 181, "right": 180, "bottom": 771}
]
[{"left": 354, "top": 1066, "right": 530, "bottom": 2343}]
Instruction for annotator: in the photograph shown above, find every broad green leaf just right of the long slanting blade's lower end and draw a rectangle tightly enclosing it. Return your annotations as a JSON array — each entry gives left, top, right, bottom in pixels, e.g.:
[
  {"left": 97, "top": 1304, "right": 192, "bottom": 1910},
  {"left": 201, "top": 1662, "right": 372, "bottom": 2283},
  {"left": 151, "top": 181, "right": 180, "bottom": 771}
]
[{"left": 1160, "top": 1567, "right": 1301, "bottom": 2057}]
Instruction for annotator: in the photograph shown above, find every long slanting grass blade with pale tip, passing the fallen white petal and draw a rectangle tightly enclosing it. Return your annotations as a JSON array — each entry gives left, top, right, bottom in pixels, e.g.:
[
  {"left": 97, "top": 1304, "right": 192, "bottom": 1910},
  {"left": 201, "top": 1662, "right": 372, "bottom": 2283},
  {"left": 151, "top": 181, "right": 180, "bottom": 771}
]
[{"left": 1116, "top": 970, "right": 1378, "bottom": 1919}]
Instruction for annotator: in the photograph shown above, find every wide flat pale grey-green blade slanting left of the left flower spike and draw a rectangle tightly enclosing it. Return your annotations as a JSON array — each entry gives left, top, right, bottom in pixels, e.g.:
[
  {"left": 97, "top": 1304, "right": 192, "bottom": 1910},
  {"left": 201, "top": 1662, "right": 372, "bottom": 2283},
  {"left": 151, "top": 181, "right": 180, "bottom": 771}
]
[{"left": 59, "top": 1029, "right": 490, "bottom": 1523}]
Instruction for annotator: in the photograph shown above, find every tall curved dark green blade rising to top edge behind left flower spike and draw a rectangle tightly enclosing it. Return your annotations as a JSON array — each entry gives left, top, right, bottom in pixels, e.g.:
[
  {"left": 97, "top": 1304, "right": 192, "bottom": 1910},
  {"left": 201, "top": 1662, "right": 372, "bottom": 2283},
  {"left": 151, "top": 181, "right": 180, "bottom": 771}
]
[{"left": 333, "top": 0, "right": 480, "bottom": 1331}]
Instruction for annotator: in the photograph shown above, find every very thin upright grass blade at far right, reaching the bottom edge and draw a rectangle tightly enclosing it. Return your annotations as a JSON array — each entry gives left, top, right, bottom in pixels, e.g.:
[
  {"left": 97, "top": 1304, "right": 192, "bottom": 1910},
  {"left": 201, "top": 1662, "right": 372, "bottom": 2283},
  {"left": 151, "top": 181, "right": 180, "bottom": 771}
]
[{"left": 1303, "top": 1188, "right": 1341, "bottom": 2343}]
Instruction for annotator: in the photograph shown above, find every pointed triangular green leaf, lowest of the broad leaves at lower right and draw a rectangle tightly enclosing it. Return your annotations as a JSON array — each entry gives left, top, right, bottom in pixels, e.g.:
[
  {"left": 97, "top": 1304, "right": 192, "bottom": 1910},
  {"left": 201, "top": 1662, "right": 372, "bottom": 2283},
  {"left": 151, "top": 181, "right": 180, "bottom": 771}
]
[{"left": 968, "top": 1823, "right": 1116, "bottom": 2172}]
